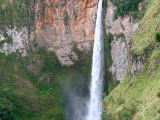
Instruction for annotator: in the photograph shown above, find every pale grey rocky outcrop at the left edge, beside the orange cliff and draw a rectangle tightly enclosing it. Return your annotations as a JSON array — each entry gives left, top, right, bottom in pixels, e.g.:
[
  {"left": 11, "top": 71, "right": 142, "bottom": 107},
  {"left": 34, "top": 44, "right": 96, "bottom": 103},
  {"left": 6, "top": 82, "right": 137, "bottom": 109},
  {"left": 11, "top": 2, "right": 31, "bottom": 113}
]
[{"left": 0, "top": 26, "right": 29, "bottom": 56}]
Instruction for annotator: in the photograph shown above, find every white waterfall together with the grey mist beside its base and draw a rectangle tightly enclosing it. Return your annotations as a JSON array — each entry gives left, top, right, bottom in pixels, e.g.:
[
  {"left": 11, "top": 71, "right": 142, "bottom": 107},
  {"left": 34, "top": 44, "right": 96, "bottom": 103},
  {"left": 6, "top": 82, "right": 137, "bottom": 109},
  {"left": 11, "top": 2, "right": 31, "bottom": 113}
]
[{"left": 65, "top": 0, "right": 105, "bottom": 120}]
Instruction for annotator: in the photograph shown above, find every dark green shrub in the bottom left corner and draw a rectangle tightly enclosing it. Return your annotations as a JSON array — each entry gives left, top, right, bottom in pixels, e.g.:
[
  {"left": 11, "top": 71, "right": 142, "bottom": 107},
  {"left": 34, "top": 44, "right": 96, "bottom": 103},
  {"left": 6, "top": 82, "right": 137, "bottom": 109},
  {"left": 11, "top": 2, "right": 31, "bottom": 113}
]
[{"left": 0, "top": 87, "right": 32, "bottom": 120}]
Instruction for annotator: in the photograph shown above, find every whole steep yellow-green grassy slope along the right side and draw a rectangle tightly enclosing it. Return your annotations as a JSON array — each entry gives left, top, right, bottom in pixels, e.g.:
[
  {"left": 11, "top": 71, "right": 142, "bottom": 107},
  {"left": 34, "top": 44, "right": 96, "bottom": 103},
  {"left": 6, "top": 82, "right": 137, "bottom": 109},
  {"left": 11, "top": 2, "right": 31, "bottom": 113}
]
[{"left": 102, "top": 0, "right": 160, "bottom": 120}]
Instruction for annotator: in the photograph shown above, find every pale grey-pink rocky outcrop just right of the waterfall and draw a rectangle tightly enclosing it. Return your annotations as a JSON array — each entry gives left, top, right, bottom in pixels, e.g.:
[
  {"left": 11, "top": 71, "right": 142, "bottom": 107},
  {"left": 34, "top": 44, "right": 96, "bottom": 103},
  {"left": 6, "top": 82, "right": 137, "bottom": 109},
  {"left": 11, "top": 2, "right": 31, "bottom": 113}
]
[{"left": 105, "top": 0, "right": 138, "bottom": 80}]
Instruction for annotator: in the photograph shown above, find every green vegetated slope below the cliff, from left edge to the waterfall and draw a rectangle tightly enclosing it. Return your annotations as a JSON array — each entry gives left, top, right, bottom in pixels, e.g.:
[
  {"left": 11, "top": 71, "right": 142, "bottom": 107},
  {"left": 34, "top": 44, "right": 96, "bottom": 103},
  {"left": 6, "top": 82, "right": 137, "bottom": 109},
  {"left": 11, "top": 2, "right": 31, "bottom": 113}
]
[{"left": 0, "top": 40, "right": 92, "bottom": 120}]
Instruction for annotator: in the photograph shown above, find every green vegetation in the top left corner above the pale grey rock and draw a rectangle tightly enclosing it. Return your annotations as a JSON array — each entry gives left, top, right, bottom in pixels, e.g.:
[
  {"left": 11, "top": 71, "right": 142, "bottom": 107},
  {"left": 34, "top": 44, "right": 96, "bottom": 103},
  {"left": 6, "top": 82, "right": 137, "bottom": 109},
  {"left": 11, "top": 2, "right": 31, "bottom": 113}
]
[{"left": 0, "top": 0, "right": 36, "bottom": 30}]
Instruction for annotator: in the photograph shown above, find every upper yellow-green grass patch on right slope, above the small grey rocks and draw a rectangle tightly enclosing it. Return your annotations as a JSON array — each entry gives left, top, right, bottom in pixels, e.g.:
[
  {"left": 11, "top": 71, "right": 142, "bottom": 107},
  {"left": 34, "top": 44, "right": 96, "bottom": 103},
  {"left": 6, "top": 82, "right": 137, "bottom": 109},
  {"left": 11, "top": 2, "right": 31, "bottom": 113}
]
[{"left": 130, "top": 0, "right": 160, "bottom": 54}]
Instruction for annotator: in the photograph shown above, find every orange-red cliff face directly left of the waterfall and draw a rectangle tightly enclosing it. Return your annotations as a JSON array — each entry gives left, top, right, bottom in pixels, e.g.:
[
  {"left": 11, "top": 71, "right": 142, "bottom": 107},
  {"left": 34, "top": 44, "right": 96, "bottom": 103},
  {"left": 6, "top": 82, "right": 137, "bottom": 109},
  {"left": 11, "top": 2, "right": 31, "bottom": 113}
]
[{"left": 32, "top": 0, "right": 98, "bottom": 65}]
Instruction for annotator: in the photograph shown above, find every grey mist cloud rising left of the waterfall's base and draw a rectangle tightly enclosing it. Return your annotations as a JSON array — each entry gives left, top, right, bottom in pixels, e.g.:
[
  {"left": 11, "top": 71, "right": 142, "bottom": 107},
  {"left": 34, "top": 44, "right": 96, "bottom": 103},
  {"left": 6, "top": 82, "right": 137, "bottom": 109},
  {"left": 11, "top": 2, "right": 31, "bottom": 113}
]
[{"left": 63, "top": 73, "right": 89, "bottom": 120}]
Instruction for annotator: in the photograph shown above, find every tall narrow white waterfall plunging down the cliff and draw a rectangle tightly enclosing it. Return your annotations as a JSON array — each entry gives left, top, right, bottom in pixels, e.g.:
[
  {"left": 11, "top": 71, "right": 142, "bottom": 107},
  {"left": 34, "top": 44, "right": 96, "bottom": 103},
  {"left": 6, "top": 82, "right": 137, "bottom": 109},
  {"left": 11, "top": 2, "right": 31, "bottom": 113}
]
[{"left": 86, "top": 0, "right": 104, "bottom": 120}]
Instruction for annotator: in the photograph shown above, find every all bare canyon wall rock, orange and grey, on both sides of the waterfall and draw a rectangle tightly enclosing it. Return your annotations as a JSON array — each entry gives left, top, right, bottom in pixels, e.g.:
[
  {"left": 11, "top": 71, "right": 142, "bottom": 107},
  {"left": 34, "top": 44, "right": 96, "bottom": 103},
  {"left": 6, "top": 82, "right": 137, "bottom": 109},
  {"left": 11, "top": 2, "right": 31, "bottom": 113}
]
[{"left": 0, "top": 0, "right": 141, "bottom": 80}]
